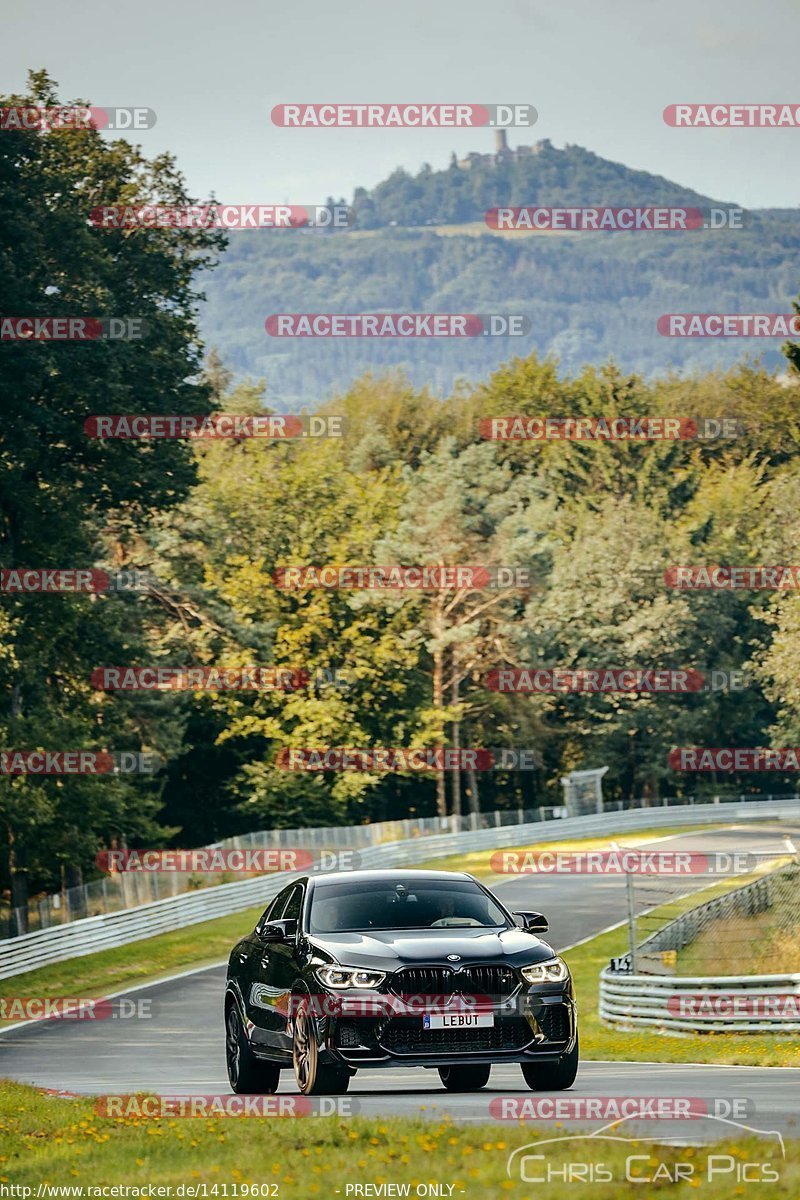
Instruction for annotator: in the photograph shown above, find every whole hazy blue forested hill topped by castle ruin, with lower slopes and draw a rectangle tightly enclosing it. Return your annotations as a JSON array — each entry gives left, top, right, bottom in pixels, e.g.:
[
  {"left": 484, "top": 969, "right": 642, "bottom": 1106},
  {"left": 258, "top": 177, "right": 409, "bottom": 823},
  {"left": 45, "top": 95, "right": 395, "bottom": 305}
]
[{"left": 203, "top": 143, "right": 800, "bottom": 407}]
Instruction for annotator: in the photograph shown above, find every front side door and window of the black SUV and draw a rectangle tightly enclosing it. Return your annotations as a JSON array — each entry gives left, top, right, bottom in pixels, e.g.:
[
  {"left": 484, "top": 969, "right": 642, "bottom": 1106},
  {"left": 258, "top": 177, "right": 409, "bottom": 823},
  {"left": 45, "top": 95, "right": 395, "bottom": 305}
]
[{"left": 249, "top": 883, "right": 303, "bottom": 1056}]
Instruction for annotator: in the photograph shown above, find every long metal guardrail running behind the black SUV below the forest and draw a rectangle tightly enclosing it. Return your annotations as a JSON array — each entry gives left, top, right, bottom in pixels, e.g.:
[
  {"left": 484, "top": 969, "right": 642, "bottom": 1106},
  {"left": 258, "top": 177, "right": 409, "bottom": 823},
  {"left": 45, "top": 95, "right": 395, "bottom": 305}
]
[{"left": 0, "top": 798, "right": 800, "bottom": 979}]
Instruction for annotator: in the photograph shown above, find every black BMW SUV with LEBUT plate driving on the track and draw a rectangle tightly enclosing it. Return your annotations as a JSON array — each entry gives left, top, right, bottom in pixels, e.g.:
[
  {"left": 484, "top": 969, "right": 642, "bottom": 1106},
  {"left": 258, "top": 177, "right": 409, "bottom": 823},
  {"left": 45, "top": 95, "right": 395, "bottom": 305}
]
[{"left": 224, "top": 870, "right": 578, "bottom": 1094}]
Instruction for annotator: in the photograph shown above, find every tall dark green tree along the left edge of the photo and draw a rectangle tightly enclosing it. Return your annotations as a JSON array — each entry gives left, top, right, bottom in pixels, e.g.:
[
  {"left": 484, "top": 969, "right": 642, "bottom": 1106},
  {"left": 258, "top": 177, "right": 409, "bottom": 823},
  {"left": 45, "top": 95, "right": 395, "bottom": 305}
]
[{"left": 0, "top": 72, "right": 221, "bottom": 908}]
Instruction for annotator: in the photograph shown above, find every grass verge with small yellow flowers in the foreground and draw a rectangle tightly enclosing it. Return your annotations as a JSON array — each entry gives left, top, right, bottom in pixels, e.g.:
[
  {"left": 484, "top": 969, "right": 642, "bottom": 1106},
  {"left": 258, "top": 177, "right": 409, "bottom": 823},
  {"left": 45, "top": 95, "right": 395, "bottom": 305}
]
[{"left": 0, "top": 1084, "right": 800, "bottom": 1200}]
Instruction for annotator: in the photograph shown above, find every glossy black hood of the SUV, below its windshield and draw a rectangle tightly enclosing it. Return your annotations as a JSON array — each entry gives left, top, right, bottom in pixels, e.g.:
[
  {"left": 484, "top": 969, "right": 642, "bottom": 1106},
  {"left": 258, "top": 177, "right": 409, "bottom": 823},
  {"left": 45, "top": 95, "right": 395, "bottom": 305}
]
[{"left": 309, "top": 929, "right": 554, "bottom": 971}]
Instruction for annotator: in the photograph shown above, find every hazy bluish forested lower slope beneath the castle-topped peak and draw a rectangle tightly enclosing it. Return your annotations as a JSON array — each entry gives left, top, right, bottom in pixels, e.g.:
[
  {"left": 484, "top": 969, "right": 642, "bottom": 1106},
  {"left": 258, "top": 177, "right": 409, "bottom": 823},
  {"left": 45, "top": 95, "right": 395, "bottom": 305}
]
[{"left": 201, "top": 214, "right": 800, "bottom": 406}]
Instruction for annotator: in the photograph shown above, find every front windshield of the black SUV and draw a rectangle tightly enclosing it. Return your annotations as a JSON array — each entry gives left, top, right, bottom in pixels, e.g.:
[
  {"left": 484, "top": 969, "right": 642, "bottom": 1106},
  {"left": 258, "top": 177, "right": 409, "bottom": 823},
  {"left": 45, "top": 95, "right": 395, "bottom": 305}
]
[{"left": 309, "top": 878, "right": 509, "bottom": 934}]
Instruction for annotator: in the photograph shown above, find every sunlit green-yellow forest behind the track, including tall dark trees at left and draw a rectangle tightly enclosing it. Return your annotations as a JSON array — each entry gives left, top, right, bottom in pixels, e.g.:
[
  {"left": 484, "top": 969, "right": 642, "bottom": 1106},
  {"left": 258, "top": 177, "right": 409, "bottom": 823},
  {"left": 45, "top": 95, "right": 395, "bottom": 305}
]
[{"left": 0, "top": 76, "right": 800, "bottom": 895}]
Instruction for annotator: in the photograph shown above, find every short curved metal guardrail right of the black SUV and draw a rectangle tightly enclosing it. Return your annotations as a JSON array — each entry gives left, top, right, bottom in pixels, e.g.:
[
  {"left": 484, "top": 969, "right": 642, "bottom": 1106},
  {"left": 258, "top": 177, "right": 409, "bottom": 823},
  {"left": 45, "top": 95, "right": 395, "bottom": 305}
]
[{"left": 600, "top": 967, "right": 800, "bottom": 1033}]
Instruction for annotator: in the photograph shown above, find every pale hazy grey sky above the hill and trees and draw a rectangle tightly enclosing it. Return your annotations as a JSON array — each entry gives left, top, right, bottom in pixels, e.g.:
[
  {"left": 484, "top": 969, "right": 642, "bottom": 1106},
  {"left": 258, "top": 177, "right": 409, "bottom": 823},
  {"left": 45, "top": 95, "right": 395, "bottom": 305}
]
[{"left": 0, "top": 0, "right": 800, "bottom": 206}]
